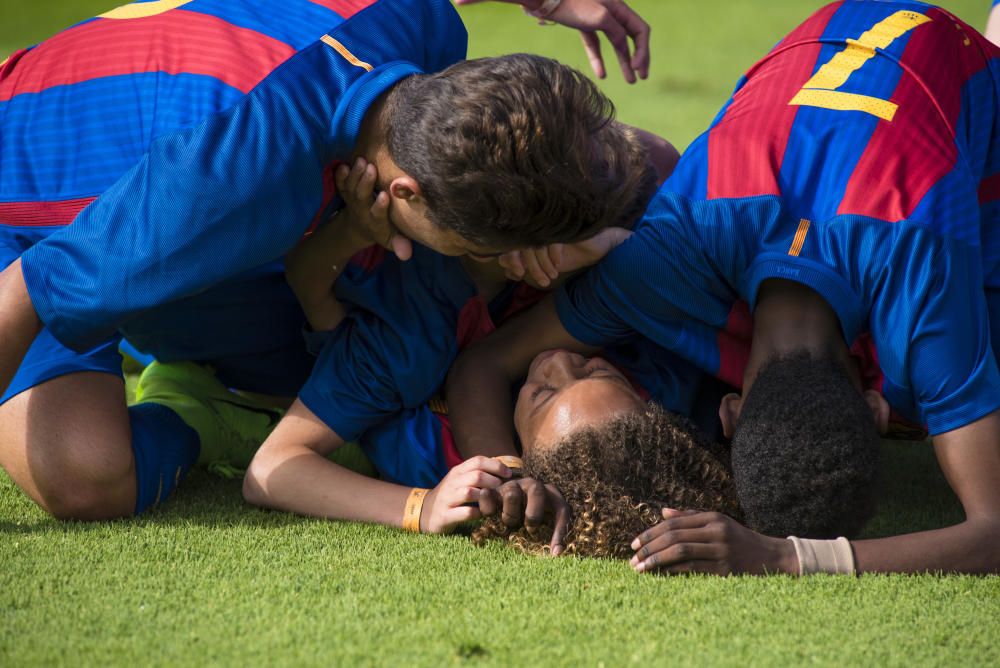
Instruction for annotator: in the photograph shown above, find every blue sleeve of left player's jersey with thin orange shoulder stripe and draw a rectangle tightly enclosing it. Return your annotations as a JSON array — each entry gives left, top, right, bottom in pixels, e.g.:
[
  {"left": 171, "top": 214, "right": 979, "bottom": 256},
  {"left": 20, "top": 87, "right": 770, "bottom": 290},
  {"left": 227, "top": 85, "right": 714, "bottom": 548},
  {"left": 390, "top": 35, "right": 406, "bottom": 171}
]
[{"left": 16, "top": 0, "right": 466, "bottom": 349}]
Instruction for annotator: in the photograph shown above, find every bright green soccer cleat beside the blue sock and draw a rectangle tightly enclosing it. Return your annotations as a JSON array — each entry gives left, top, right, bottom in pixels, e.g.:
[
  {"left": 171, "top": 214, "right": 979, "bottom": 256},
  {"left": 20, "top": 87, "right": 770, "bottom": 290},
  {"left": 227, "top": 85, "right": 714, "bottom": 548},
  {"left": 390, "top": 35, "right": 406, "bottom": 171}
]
[{"left": 135, "top": 362, "right": 284, "bottom": 478}]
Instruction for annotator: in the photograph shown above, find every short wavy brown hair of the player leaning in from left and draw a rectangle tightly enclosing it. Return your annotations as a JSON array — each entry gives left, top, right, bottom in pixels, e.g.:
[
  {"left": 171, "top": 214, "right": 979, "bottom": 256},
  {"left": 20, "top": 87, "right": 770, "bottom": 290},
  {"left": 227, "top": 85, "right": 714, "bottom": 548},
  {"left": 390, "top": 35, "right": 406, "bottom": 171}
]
[{"left": 383, "top": 54, "right": 656, "bottom": 248}]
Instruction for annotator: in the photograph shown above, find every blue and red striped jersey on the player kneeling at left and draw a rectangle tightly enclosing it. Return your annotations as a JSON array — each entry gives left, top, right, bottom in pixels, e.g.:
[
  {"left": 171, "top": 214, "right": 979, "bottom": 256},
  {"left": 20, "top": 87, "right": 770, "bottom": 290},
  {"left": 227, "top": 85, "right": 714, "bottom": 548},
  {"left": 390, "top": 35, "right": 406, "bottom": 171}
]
[{"left": 0, "top": 0, "right": 466, "bottom": 349}]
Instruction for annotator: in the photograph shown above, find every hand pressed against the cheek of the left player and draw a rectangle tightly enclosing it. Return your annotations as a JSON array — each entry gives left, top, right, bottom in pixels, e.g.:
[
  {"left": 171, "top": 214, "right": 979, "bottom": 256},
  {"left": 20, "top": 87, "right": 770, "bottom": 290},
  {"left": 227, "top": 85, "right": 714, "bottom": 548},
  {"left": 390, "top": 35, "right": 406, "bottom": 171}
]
[{"left": 334, "top": 158, "right": 413, "bottom": 260}]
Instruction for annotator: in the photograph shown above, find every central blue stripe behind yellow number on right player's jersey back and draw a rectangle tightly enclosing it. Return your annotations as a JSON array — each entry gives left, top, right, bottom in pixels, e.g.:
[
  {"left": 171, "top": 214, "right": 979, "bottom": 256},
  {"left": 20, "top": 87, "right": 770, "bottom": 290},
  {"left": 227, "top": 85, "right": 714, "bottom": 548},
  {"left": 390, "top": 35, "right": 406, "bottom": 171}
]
[{"left": 778, "top": 3, "right": 910, "bottom": 221}]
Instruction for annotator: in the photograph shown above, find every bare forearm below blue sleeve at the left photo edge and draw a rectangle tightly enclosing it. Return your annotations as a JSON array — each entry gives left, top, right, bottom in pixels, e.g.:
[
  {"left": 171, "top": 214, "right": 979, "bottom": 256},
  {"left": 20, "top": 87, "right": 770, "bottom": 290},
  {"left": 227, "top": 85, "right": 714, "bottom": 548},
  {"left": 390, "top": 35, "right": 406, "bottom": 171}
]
[{"left": 0, "top": 259, "right": 42, "bottom": 393}]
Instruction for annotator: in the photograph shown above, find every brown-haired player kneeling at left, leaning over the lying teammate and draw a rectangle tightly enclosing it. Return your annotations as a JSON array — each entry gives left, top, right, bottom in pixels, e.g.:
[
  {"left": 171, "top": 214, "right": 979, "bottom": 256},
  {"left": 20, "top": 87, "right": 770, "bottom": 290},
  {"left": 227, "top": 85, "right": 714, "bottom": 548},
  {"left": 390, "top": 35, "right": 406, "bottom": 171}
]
[{"left": 0, "top": 0, "right": 645, "bottom": 519}]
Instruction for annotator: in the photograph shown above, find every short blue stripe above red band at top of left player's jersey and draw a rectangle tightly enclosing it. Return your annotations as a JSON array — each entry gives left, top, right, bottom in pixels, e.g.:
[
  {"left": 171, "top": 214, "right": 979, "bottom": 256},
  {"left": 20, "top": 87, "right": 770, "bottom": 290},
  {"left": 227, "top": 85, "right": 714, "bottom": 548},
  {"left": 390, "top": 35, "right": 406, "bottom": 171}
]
[{"left": 180, "top": 0, "right": 344, "bottom": 51}]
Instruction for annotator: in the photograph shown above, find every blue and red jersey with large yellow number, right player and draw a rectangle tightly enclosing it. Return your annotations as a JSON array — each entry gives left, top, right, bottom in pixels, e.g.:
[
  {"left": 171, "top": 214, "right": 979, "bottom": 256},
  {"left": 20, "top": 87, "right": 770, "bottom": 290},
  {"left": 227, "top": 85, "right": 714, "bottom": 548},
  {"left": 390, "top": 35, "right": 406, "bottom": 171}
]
[{"left": 558, "top": 0, "right": 1000, "bottom": 434}]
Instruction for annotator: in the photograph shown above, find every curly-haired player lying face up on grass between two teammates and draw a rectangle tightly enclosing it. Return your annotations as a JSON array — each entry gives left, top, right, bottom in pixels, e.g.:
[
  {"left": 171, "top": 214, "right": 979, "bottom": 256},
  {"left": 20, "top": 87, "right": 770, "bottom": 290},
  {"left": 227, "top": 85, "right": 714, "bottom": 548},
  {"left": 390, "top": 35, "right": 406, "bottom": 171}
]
[{"left": 244, "top": 153, "right": 875, "bottom": 556}]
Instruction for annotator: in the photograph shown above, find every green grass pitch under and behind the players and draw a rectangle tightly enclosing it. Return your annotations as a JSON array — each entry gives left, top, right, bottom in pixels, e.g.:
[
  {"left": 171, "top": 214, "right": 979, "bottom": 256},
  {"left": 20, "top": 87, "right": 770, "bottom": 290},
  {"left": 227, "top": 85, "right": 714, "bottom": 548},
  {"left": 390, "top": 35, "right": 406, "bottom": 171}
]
[{"left": 0, "top": 0, "right": 1000, "bottom": 666}]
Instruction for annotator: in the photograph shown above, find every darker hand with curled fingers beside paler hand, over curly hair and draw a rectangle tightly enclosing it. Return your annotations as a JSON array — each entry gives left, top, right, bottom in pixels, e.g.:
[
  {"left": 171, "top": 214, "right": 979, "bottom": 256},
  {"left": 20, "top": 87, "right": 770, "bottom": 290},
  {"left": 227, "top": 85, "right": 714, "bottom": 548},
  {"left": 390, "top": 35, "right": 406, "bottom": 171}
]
[{"left": 479, "top": 478, "right": 572, "bottom": 556}]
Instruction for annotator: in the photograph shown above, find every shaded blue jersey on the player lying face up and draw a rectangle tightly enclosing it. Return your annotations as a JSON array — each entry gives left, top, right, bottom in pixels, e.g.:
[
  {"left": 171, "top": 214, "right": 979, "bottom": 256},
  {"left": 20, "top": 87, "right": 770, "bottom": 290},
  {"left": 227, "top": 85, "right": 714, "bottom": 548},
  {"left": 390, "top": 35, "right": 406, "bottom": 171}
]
[{"left": 299, "top": 245, "right": 717, "bottom": 487}]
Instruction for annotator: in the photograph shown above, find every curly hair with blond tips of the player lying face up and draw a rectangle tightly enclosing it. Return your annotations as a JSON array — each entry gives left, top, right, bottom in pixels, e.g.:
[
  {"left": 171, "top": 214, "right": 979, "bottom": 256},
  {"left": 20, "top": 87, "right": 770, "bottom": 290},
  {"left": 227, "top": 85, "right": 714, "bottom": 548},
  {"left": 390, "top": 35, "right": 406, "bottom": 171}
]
[{"left": 472, "top": 403, "right": 741, "bottom": 559}]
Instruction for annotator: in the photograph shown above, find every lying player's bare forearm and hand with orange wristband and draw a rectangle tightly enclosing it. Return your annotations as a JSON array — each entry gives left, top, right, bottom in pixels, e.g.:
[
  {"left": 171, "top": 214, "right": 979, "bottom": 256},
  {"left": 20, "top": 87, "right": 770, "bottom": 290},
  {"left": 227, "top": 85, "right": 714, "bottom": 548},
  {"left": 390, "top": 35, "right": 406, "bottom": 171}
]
[{"left": 243, "top": 401, "right": 511, "bottom": 533}]
